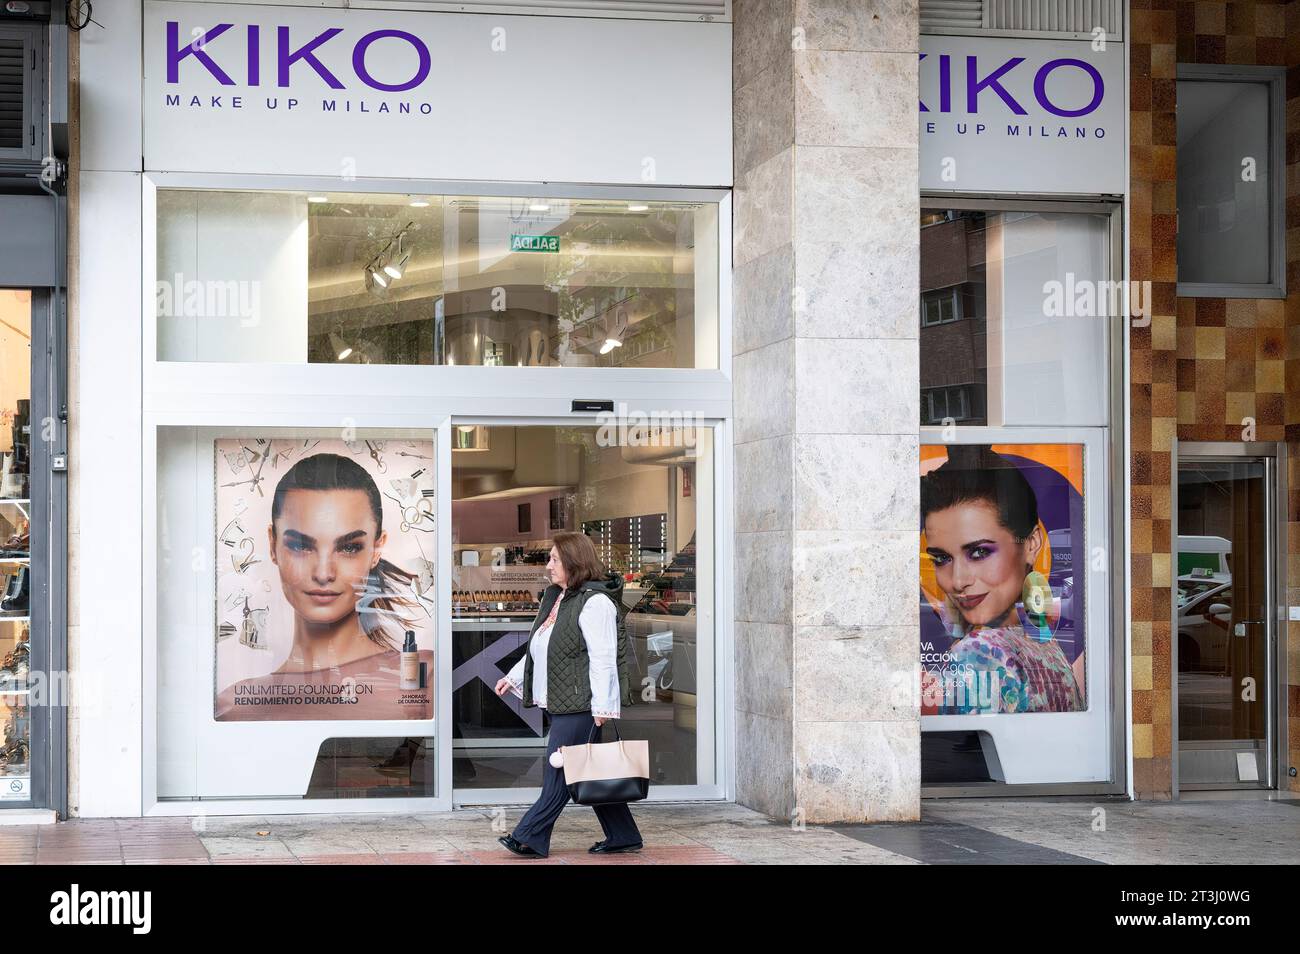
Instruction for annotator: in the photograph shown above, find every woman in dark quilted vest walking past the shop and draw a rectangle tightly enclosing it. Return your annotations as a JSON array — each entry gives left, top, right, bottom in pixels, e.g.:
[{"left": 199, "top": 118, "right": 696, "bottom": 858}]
[{"left": 495, "top": 533, "right": 641, "bottom": 858}]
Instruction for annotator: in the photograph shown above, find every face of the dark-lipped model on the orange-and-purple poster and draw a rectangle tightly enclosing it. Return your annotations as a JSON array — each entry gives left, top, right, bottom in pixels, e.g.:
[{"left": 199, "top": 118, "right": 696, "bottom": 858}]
[{"left": 926, "top": 500, "right": 1043, "bottom": 628}]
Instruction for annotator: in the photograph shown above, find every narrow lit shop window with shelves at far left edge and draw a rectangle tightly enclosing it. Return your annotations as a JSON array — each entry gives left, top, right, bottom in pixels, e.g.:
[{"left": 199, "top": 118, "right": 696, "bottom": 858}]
[{"left": 0, "top": 290, "right": 39, "bottom": 806}]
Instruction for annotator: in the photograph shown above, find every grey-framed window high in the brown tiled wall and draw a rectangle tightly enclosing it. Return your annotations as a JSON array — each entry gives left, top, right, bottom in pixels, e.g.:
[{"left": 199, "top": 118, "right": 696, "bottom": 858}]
[{"left": 1178, "top": 65, "right": 1286, "bottom": 298}]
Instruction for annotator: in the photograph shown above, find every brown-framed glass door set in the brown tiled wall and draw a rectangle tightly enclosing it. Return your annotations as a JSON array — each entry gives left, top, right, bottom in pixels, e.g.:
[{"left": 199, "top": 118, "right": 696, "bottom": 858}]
[{"left": 1175, "top": 450, "right": 1277, "bottom": 790}]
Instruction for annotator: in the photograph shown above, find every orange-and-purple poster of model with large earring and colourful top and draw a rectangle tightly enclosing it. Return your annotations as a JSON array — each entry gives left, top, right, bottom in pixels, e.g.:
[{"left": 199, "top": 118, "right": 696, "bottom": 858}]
[{"left": 920, "top": 445, "right": 1087, "bottom": 715}]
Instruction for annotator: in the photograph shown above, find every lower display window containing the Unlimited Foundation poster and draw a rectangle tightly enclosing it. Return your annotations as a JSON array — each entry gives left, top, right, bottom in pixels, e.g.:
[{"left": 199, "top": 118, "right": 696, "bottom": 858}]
[{"left": 159, "top": 428, "right": 437, "bottom": 797}]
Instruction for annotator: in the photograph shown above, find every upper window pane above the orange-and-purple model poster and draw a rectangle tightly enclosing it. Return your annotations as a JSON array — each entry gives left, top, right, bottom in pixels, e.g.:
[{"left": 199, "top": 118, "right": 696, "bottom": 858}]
[{"left": 920, "top": 209, "right": 1118, "bottom": 426}]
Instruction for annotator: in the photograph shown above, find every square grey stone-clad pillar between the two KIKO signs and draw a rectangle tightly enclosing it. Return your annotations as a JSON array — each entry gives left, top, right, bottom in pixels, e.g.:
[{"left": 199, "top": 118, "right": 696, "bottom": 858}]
[{"left": 733, "top": 0, "right": 920, "bottom": 821}]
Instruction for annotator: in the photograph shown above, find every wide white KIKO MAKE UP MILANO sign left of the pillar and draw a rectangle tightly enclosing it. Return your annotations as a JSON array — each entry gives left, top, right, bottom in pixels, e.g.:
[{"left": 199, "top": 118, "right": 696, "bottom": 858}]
[{"left": 142, "top": 0, "right": 732, "bottom": 185}]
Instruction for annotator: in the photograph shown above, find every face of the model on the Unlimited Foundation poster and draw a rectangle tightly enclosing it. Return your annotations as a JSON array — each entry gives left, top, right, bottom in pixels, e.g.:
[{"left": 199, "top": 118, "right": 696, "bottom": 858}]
[{"left": 267, "top": 490, "right": 387, "bottom": 636}]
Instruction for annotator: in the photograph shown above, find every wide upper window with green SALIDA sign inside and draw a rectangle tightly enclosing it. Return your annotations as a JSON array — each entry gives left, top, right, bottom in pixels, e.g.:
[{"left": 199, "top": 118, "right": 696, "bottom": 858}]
[{"left": 156, "top": 190, "right": 719, "bottom": 368}]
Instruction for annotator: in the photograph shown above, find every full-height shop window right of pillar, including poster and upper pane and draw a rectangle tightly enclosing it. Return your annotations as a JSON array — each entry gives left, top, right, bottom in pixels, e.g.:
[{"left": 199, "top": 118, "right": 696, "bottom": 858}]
[{"left": 919, "top": 203, "right": 1128, "bottom": 786}]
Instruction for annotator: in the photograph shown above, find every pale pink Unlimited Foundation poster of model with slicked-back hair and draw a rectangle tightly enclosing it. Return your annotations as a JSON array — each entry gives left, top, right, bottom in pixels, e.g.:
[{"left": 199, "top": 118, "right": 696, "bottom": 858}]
[{"left": 215, "top": 438, "right": 437, "bottom": 721}]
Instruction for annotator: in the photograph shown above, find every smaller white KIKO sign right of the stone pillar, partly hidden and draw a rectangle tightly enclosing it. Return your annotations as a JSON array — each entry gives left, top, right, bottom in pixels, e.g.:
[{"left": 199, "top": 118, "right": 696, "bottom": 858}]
[{"left": 918, "top": 36, "right": 1126, "bottom": 194}]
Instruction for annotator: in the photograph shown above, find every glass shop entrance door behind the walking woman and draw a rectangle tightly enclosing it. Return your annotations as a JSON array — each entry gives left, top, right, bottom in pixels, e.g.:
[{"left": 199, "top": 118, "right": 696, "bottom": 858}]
[{"left": 451, "top": 425, "right": 714, "bottom": 789}]
